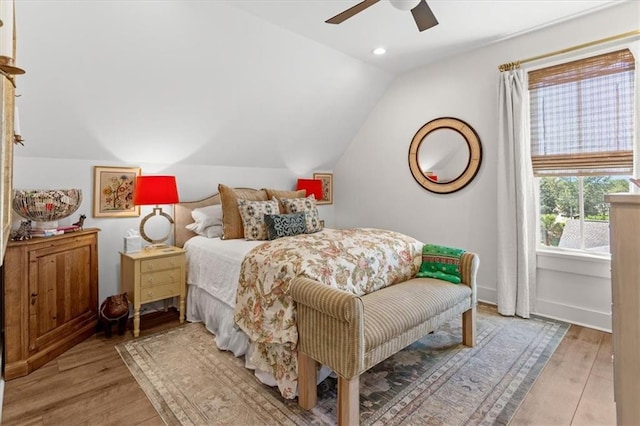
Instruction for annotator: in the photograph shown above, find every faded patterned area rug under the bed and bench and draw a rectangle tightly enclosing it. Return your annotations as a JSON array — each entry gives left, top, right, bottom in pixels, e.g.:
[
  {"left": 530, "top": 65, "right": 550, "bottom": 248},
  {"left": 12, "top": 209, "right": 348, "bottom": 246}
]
[{"left": 116, "top": 305, "right": 569, "bottom": 425}]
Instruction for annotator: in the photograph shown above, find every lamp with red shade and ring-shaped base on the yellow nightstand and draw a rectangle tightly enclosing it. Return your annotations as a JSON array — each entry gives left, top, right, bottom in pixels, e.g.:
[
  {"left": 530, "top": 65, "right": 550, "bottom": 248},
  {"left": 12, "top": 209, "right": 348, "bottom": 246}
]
[{"left": 133, "top": 176, "right": 178, "bottom": 244}]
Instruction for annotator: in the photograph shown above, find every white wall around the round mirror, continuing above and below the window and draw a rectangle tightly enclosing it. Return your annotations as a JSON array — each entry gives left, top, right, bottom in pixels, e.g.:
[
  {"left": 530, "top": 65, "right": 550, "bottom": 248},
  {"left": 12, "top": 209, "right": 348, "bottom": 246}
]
[{"left": 334, "top": 1, "right": 640, "bottom": 329}]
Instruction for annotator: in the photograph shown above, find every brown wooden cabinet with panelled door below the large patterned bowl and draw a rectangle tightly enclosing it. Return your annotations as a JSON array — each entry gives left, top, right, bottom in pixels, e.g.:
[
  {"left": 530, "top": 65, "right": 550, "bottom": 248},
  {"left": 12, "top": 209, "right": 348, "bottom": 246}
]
[{"left": 3, "top": 229, "right": 99, "bottom": 380}]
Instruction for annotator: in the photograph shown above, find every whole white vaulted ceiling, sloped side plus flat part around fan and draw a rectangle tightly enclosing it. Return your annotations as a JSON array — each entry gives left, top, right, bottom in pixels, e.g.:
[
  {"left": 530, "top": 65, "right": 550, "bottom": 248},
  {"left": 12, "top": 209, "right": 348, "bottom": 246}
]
[{"left": 16, "top": 0, "right": 624, "bottom": 174}]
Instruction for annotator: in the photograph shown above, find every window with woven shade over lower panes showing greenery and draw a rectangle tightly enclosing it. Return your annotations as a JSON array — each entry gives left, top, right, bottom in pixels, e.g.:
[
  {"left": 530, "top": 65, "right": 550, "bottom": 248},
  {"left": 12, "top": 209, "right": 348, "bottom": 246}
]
[{"left": 529, "top": 49, "right": 636, "bottom": 253}]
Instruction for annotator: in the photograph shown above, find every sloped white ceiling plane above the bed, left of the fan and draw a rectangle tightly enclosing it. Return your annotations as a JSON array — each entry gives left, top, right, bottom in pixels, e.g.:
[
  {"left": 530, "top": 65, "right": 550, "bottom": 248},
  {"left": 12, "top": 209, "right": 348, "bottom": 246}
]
[{"left": 16, "top": 0, "right": 392, "bottom": 171}]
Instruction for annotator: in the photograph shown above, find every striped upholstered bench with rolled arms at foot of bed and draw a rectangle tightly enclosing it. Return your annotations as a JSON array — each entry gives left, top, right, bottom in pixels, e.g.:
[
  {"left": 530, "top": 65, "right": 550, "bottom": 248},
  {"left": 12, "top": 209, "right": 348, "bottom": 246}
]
[{"left": 291, "top": 252, "right": 479, "bottom": 425}]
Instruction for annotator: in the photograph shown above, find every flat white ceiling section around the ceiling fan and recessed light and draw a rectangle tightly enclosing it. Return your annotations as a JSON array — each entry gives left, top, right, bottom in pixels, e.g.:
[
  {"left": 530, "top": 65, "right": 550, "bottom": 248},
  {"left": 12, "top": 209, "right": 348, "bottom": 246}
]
[{"left": 229, "top": 0, "right": 624, "bottom": 74}]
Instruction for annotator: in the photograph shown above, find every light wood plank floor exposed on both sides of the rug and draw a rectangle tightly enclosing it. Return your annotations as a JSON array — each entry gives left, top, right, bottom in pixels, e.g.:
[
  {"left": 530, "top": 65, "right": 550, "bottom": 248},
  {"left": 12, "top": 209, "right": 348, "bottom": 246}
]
[{"left": 2, "top": 312, "right": 615, "bottom": 426}]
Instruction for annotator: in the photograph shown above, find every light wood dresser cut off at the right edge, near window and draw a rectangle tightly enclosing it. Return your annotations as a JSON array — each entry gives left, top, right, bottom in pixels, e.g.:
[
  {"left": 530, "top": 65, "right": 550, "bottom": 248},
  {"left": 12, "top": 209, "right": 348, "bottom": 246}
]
[{"left": 605, "top": 193, "right": 640, "bottom": 425}]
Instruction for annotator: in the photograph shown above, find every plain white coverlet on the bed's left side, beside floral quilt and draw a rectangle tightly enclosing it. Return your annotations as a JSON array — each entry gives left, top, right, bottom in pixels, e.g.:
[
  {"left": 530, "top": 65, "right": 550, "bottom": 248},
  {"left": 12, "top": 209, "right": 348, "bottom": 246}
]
[{"left": 184, "top": 236, "right": 264, "bottom": 309}]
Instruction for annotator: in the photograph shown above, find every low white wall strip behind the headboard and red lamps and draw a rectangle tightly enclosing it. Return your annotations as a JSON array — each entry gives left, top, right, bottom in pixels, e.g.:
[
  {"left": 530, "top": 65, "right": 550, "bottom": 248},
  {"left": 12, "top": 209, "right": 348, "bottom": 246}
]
[{"left": 14, "top": 157, "right": 334, "bottom": 301}]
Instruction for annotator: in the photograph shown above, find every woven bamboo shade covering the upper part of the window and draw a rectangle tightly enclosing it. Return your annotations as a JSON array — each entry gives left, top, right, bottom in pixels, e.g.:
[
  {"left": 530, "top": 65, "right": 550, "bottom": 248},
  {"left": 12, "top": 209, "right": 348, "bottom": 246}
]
[{"left": 529, "top": 49, "right": 635, "bottom": 176}]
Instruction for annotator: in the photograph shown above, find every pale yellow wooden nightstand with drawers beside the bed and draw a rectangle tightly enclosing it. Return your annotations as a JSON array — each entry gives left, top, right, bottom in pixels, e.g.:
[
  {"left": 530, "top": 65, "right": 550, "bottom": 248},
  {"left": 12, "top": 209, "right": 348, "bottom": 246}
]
[{"left": 120, "top": 246, "right": 187, "bottom": 337}]
